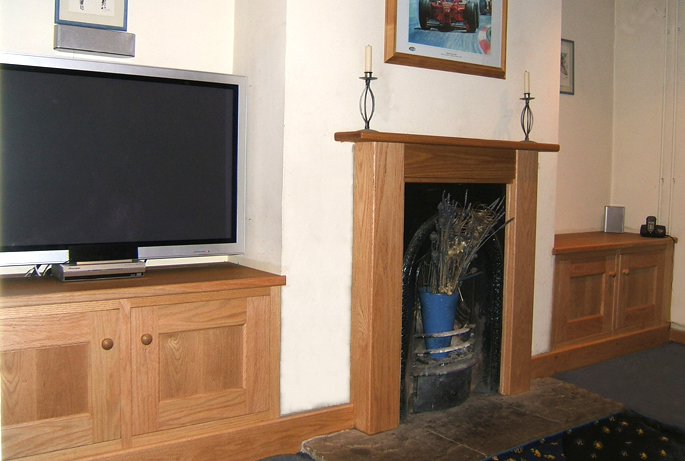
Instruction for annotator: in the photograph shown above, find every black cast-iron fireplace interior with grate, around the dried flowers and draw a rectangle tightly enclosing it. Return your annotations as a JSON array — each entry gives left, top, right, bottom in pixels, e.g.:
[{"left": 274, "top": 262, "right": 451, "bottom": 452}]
[{"left": 400, "top": 183, "right": 506, "bottom": 420}]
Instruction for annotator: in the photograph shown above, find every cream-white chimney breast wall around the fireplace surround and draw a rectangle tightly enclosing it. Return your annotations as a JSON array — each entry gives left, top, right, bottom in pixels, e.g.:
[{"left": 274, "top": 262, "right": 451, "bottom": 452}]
[{"left": 274, "top": 0, "right": 561, "bottom": 413}]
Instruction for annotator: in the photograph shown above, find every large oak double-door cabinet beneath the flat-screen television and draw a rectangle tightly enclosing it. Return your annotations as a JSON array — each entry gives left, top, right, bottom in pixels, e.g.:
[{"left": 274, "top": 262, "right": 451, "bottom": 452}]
[{"left": 0, "top": 264, "right": 284, "bottom": 459}]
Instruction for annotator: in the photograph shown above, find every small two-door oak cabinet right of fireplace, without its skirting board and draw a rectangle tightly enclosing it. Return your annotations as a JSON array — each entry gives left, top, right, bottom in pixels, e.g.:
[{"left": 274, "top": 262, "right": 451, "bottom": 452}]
[{"left": 552, "top": 232, "right": 673, "bottom": 349}]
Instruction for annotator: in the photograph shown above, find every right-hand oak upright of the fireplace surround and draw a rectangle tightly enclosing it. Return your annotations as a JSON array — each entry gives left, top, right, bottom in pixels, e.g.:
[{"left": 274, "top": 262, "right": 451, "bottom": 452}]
[{"left": 500, "top": 151, "right": 538, "bottom": 395}]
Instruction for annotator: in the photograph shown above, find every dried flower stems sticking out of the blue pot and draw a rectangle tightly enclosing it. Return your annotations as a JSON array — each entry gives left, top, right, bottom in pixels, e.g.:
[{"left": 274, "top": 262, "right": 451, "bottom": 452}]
[{"left": 421, "top": 192, "right": 514, "bottom": 295}]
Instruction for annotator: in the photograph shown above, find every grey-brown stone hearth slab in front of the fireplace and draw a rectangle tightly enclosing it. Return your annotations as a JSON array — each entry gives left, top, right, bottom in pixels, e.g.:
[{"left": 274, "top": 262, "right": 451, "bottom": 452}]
[{"left": 302, "top": 378, "right": 623, "bottom": 461}]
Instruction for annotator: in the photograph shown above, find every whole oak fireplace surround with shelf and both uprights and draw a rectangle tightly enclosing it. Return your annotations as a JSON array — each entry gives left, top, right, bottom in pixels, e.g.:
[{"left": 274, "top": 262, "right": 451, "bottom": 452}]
[{"left": 335, "top": 131, "right": 559, "bottom": 433}]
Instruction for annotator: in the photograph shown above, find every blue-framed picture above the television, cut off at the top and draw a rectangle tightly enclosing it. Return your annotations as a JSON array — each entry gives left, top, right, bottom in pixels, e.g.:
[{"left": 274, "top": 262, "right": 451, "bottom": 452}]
[{"left": 55, "top": 0, "right": 128, "bottom": 30}]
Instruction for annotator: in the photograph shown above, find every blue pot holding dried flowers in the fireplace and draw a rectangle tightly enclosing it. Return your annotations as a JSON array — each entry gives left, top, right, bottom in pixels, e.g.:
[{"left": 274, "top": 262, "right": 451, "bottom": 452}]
[{"left": 419, "top": 288, "right": 459, "bottom": 359}]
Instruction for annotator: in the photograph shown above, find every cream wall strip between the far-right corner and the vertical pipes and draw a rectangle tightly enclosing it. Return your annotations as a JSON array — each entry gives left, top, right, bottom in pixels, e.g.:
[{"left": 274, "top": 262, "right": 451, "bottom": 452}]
[{"left": 612, "top": 0, "right": 671, "bottom": 231}]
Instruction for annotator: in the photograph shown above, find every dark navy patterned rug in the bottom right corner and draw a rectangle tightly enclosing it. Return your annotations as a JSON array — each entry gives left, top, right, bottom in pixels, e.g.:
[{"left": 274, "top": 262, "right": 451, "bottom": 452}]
[{"left": 486, "top": 410, "right": 685, "bottom": 461}]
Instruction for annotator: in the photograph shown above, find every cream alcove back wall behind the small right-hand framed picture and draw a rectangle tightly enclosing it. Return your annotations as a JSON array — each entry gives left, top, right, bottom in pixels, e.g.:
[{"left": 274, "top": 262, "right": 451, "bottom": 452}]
[{"left": 555, "top": 0, "right": 622, "bottom": 233}]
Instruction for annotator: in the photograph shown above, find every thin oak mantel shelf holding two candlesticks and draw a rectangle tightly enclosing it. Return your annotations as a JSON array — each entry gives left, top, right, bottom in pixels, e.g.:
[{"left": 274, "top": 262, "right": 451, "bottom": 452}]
[{"left": 335, "top": 130, "right": 559, "bottom": 152}]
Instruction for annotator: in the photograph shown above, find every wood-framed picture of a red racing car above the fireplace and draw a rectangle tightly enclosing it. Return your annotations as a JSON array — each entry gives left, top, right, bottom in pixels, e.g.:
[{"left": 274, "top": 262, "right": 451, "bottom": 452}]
[{"left": 385, "top": 0, "right": 507, "bottom": 78}]
